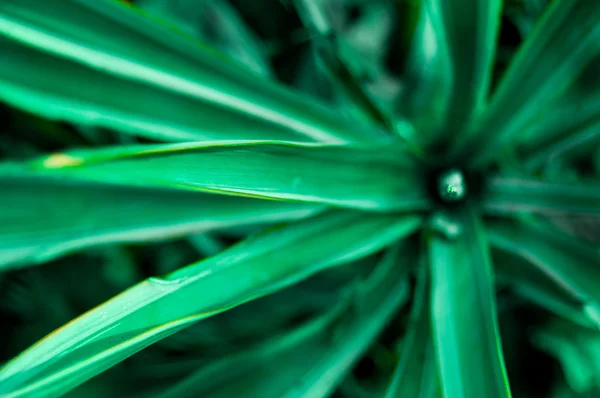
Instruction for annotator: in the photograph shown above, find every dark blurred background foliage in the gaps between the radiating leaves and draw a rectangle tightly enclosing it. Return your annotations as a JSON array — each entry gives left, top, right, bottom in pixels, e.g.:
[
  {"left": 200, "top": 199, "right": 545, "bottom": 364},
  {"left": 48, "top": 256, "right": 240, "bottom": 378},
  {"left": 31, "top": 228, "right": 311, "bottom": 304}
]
[{"left": 0, "top": 0, "right": 600, "bottom": 398}]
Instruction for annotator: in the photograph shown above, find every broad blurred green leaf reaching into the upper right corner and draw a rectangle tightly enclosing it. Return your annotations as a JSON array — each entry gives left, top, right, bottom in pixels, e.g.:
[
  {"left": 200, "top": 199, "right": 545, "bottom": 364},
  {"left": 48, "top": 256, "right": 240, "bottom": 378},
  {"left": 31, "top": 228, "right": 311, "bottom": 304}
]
[{"left": 463, "top": 0, "right": 600, "bottom": 165}]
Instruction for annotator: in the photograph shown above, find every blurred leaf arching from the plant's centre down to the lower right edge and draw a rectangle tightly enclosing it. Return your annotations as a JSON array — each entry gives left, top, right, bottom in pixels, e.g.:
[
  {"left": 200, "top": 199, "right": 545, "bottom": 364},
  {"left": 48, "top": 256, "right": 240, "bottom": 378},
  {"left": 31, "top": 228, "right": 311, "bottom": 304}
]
[{"left": 489, "top": 220, "right": 600, "bottom": 327}]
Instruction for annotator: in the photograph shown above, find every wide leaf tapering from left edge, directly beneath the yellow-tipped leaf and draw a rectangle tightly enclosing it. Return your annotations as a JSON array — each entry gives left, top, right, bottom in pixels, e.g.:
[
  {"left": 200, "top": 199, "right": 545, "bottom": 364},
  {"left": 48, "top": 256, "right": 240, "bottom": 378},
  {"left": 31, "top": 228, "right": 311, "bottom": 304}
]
[{"left": 0, "top": 173, "right": 323, "bottom": 270}]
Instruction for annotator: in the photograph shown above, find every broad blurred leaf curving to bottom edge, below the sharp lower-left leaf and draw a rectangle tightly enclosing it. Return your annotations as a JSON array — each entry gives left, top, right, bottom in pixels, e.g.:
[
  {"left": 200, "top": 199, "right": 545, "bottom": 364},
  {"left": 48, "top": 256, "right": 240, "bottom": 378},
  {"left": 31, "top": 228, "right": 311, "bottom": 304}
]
[{"left": 159, "top": 246, "right": 411, "bottom": 398}]
